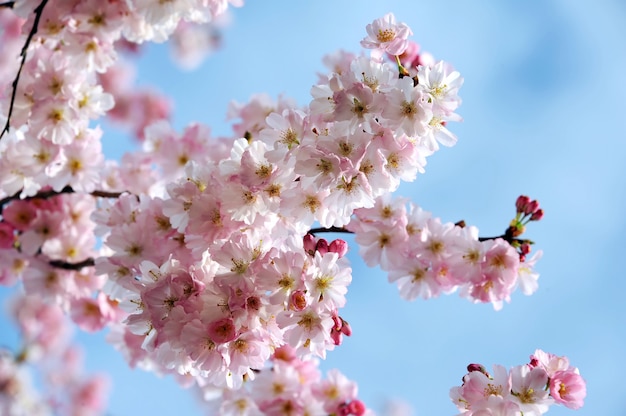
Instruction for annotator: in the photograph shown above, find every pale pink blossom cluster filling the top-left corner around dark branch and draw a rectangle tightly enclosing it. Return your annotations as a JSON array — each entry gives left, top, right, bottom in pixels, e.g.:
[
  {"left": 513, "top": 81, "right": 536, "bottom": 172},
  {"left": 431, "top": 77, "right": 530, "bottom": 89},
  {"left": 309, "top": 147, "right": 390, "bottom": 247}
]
[{"left": 0, "top": 0, "right": 240, "bottom": 197}]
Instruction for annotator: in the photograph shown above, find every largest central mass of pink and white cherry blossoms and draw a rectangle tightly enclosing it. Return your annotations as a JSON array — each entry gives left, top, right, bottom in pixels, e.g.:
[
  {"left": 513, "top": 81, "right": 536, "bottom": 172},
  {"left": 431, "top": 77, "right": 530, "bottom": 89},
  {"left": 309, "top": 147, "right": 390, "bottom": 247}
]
[{"left": 94, "top": 10, "right": 470, "bottom": 396}]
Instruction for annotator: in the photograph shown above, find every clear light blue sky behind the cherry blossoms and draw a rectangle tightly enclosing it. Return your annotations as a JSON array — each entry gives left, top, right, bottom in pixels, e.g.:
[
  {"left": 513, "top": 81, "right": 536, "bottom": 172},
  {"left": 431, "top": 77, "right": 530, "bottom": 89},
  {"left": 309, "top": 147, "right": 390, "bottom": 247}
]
[{"left": 0, "top": 0, "right": 626, "bottom": 416}]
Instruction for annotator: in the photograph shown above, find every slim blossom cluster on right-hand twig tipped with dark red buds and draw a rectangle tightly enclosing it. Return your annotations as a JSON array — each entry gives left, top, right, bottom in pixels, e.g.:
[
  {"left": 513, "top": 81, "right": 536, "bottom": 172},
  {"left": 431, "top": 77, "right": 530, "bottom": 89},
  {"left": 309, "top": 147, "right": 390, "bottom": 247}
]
[{"left": 348, "top": 196, "right": 543, "bottom": 310}]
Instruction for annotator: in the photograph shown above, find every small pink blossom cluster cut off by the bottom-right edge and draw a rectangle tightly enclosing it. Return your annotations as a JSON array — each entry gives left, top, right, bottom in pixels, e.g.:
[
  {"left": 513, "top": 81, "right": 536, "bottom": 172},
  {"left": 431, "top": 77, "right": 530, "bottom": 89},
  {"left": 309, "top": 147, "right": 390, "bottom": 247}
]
[{"left": 450, "top": 350, "right": 587, "bottom": 416}]
